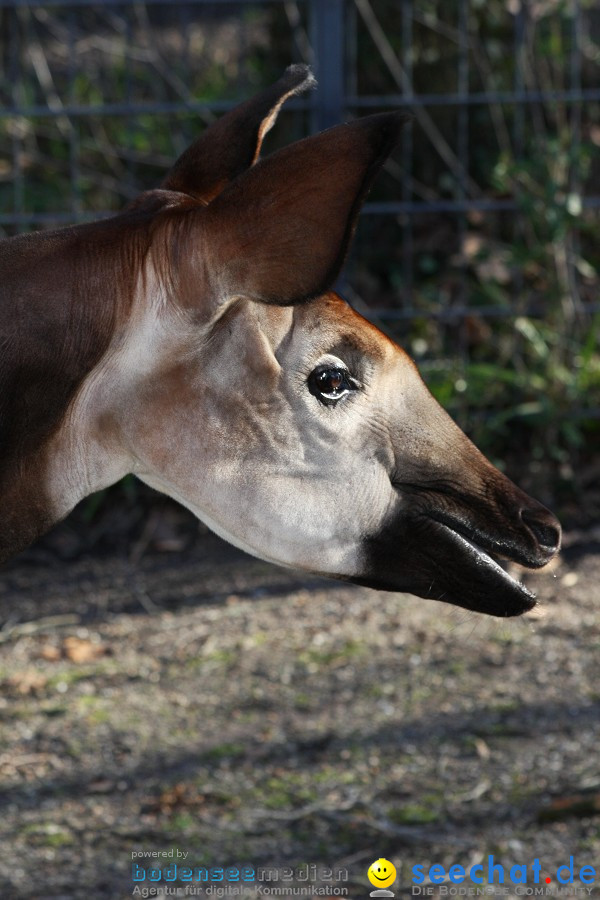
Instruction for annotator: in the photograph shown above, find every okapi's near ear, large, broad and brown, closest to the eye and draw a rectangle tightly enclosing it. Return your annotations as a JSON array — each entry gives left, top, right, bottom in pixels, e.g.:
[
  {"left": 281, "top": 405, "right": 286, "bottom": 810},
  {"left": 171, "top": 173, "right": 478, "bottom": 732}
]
[{"left": 199, "top": 113, "right": 409, "bottom": 306}]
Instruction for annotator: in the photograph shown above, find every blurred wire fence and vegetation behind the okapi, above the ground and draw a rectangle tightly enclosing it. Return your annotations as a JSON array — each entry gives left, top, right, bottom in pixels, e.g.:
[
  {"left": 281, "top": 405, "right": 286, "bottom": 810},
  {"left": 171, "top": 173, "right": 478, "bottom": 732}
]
[{"left": 0, "top": 0, "right": 600, "bottom": 524}]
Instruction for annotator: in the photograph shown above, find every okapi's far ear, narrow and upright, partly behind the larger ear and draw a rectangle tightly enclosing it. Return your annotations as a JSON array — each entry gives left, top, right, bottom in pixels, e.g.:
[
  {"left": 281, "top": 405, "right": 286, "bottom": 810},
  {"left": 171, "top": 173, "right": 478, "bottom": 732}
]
[{"left": 161, "top": 65, "right": 316, "bottom": 203}]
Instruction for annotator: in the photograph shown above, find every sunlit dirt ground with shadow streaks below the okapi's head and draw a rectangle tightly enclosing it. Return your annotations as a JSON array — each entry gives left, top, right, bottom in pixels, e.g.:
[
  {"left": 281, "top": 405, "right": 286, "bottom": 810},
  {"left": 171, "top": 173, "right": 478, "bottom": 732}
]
[{"left": 0, "top": 507, "right": 600, "bottom": 900}]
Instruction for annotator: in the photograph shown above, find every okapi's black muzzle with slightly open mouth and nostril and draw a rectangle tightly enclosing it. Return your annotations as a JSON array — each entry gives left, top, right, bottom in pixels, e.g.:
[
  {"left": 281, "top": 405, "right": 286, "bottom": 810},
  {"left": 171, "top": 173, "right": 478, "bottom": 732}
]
[{"left": 352, "top": 484, "right": 560, "bottom": 617}]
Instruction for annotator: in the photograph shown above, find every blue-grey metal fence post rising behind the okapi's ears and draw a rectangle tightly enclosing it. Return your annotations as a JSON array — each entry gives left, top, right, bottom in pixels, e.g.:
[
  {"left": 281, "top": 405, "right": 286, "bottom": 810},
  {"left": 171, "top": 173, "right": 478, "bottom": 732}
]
[{"left": 310, "top": 0, "right": 346, "bottom": 131}]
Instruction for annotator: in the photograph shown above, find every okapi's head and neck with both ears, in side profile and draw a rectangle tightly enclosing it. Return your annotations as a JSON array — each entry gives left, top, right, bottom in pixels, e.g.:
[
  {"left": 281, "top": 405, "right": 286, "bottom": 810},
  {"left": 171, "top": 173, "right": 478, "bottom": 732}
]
[{"left": 0, "top": 66, "right": 560, "bottom": 616}]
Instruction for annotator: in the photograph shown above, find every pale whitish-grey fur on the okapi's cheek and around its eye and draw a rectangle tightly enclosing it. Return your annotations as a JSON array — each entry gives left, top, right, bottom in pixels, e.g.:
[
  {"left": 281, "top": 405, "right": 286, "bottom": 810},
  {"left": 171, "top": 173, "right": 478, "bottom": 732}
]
[{"left": 50, "top": 277, "right": 408, "bottom": 576}]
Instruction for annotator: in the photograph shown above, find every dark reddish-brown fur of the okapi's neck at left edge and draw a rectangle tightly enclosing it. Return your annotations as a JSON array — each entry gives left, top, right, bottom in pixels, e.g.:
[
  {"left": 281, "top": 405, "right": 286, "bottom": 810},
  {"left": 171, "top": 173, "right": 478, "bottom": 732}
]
[{"left": 0, "top": 214, "right": 156, "bottom": 559}]
